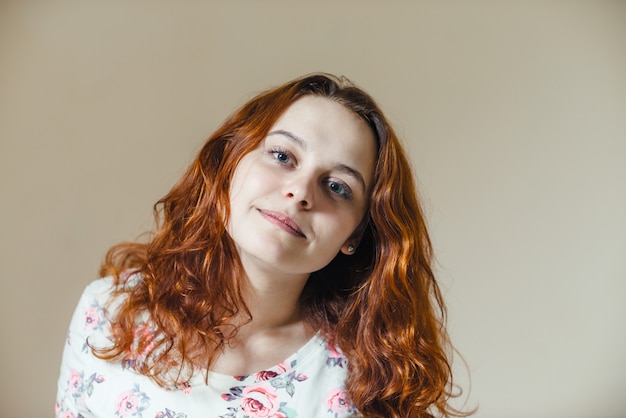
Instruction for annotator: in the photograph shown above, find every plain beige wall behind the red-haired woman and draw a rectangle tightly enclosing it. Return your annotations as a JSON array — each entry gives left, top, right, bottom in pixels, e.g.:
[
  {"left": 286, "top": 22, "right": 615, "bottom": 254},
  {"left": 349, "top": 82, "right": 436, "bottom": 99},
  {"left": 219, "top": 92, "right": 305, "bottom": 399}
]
[{"left": 0, "top": 0, "right": 626, "bottom": 418}]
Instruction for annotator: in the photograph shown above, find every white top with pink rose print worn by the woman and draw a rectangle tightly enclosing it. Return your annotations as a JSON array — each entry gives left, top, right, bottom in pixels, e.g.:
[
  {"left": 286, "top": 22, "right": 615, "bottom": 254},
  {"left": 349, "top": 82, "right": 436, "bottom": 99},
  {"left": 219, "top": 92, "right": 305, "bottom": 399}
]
[{"left": 55, "top": 277, "right": 358, "bottom": 418}]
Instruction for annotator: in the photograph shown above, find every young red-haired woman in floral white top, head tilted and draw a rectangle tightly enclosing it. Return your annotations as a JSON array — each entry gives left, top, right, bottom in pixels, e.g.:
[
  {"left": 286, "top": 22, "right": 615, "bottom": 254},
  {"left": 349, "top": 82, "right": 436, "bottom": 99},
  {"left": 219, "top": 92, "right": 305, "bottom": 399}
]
[{"left": 56, "top": 74, "right": 468, "bottom": 418}]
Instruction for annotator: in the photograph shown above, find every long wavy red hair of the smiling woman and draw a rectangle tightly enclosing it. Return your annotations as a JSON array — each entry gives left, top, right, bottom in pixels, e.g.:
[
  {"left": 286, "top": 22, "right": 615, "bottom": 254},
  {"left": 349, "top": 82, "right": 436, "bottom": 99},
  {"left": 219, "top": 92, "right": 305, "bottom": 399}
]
[{"left": 93, "top": 74, "right": 463, "bottom": 417}]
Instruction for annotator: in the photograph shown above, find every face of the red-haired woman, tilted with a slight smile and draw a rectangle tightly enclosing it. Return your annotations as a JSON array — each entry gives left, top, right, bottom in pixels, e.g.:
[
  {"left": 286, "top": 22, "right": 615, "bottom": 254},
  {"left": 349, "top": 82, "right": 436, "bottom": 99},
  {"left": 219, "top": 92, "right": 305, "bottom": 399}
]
[{"left": 228, "top": 96, "right": 376, "bottom": 276}]
